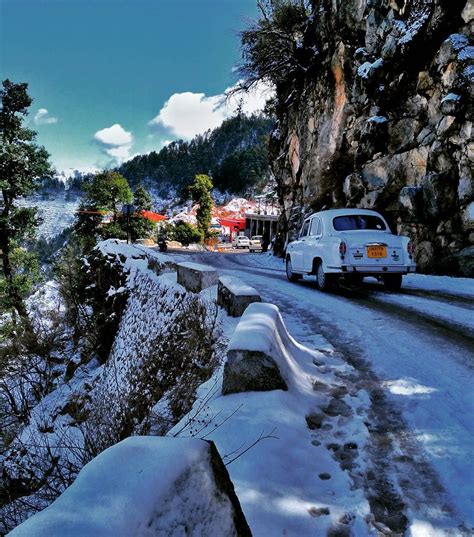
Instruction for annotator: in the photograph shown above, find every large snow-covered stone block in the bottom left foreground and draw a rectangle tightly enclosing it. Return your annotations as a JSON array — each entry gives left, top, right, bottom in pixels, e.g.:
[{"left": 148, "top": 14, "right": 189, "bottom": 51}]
[{"left": 10, "top": 437, "right": 250, "bottom": 537}]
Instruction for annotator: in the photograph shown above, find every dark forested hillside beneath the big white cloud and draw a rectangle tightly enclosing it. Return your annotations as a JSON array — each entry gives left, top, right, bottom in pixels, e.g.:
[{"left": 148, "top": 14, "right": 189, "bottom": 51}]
[{"left": 118, "top": 114, "right": 274, "bottom": 195}]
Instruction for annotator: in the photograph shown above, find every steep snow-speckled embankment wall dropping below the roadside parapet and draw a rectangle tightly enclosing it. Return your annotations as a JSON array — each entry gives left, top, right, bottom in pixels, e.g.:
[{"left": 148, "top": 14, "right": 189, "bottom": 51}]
[{"left": 92, "top": 255, "right": 220, "bottom": 435}]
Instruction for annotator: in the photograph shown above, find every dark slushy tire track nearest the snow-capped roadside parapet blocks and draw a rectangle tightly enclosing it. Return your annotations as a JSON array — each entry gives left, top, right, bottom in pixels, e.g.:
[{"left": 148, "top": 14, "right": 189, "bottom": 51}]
[{"left": 233, "top": 275, "right": 467, "bottom": 535}]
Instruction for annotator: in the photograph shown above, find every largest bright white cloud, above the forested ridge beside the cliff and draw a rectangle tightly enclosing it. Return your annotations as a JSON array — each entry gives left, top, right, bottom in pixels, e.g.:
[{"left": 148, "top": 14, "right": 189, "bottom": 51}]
[{"left": 149, "top": 79, "right": 272, "bottom": 139}]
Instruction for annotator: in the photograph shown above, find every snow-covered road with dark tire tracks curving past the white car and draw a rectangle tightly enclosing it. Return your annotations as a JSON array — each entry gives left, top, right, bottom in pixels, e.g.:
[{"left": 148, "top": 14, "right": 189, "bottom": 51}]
[{"left": 174, "top": 253, "right": 474, "bottom": 534}]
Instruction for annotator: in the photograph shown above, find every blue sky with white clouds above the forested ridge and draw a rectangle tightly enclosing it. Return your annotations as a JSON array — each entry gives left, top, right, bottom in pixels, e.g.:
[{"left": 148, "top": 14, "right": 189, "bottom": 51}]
[{"left": 0, "top": 0, "right": 268, "bottom": 169}]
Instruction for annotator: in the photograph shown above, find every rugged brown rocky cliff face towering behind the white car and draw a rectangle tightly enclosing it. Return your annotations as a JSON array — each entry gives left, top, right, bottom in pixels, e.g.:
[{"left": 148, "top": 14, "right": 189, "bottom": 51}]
[{"left": 271, "top": 0, "right": 474, "bottom": 275}]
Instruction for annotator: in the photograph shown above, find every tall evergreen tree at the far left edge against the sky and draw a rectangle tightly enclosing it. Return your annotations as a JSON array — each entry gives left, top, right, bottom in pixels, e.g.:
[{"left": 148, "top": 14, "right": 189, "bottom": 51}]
[{"left": 0, "top": 79, "right": 51, "bottom": 321}]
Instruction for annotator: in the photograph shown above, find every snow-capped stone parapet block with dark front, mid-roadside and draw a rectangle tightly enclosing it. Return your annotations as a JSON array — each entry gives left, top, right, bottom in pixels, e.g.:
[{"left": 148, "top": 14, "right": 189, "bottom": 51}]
[{"left": 222, "top": 302, "right": 288, "bottom": 395}]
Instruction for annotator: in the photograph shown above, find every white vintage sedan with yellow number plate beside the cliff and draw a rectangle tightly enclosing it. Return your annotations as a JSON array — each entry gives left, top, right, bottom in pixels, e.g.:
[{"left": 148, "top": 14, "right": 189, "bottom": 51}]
[{"left": 286, "top": 209, "right": 416, "bottom": 291}]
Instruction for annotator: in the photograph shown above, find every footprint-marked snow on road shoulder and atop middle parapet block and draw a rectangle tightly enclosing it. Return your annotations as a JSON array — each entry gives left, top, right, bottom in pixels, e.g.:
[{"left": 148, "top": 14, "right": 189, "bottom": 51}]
[{"left": 168, "top": 303, "right": 371, "bottom": 537}]
